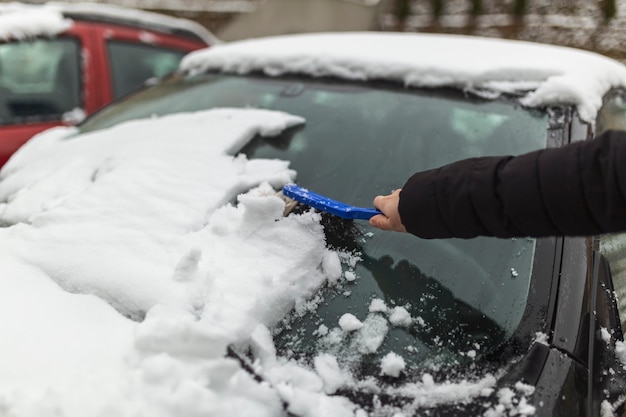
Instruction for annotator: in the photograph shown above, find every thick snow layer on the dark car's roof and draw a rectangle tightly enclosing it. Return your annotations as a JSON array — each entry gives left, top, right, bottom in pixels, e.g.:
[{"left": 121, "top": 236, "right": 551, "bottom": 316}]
[{"left": 180, "top": 32, "right": 626, "bottom": 122}]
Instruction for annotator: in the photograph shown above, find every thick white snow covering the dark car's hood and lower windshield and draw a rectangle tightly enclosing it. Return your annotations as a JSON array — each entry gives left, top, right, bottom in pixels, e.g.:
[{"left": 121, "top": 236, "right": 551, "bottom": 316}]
[{"left": 0, "top": 109, "right": 534, "bottom": 417}]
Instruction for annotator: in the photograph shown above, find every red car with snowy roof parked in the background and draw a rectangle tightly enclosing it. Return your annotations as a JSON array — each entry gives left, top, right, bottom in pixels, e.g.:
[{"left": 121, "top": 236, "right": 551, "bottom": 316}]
[{"left": 0, "top": 3, "right": 218, "bottom": 166}]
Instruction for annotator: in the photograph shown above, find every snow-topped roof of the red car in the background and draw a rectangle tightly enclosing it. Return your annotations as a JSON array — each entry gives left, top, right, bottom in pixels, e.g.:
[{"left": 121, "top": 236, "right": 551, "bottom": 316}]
[{"left": 0, "top": 2, "right": 220, "bottom": 45}]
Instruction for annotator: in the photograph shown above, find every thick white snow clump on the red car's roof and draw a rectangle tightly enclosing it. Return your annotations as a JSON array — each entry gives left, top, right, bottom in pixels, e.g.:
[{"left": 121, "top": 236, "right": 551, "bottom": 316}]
[{"left": 0, "top": 3, "right": 72, "bottom": 41}]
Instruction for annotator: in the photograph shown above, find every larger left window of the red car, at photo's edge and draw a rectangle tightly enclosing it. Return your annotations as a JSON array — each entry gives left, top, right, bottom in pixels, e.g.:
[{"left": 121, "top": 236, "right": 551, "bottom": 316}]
[{"left": 0, "top": 38, "right": 81, "bottom": 124}]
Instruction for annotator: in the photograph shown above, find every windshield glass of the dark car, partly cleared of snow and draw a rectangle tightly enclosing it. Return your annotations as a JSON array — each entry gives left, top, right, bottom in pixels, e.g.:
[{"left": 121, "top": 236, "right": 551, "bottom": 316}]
[{"left": 80, "top": 74, "right": 548, "bottom": 375}]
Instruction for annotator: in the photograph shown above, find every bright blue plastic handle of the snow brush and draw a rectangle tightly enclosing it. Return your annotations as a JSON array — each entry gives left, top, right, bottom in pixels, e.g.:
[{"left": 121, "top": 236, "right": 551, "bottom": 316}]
[{"left": 283, "top": 184, "right": 382, "bottom": 220}]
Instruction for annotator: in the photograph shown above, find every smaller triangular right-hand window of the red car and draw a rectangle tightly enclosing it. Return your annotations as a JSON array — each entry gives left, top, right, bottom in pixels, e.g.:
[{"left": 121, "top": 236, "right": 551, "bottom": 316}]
[{"left": 107, "top": 41, "right": 185, "bottom": 98}]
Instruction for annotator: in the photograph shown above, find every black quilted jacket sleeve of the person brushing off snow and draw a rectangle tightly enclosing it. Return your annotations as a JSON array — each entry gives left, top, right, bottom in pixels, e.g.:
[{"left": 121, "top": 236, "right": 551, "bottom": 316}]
[{"left": 398, "top": 131, "right": 626, "bottom": 238}]
